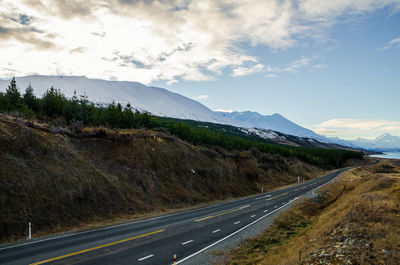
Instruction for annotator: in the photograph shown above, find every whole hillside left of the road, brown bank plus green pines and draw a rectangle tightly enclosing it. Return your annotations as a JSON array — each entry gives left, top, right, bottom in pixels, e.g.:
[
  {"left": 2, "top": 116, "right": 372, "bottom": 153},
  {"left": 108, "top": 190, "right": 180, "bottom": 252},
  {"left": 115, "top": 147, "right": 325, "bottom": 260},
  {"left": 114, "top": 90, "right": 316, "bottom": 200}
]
[{"left": 0, "top": 79, "right": 361, "bottom": 240}]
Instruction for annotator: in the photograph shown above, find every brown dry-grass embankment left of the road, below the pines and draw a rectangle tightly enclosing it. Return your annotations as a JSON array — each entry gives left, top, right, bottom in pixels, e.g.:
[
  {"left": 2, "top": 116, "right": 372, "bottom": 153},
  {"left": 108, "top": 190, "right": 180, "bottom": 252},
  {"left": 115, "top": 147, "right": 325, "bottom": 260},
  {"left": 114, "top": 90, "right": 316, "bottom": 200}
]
[{"left": 0, "top": 120, "right": 323, "bottom": 241}]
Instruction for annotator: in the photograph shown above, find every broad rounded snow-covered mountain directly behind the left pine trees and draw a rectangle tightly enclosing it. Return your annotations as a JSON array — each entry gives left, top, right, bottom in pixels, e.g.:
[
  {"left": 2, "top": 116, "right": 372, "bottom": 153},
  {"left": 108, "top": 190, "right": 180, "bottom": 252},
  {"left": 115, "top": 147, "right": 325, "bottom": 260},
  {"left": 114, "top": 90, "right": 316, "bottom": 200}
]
[{"left": 0, "top": 75, "right": 239, "bottom": 126}]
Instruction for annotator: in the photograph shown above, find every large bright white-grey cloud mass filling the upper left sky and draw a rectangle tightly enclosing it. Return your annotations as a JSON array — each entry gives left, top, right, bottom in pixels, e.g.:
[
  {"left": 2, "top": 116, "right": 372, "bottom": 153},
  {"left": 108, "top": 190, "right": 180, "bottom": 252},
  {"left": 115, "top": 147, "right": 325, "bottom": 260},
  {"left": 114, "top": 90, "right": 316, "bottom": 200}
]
[{"left": 0, "top": 0, "right": 399, "bottom": 84}]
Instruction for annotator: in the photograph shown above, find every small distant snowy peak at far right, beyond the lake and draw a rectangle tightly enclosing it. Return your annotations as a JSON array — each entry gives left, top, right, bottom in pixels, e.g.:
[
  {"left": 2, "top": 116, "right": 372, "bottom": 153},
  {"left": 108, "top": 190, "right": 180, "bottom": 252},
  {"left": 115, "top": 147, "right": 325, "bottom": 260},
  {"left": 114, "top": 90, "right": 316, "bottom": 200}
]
[{"left": 351, "top": 133, "right": 400, "bottom": 151}]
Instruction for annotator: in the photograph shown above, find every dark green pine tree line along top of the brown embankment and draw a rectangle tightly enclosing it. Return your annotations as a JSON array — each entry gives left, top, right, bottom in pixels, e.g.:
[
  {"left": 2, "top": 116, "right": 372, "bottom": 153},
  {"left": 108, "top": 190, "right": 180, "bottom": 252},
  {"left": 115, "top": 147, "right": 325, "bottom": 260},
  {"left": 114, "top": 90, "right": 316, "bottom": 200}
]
[{"left": 0, "top": 78, "right": 362, "bottom": 168}]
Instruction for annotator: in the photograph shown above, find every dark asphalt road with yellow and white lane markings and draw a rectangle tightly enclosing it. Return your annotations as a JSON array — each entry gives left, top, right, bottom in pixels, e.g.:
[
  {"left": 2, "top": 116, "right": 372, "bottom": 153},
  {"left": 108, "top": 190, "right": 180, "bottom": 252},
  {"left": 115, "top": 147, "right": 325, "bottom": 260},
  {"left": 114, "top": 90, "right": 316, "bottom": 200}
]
[{"left": 0, "top": 169, "right": 345, "bottom": 265}]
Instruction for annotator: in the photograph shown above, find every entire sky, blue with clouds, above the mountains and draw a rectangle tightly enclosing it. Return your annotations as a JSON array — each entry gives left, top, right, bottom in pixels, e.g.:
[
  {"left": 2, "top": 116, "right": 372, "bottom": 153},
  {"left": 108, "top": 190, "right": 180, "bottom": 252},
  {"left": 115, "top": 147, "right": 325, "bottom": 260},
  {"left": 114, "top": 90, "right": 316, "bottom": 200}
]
[{"left": 0, "top": 0, "right": 400, "bottom": 139}]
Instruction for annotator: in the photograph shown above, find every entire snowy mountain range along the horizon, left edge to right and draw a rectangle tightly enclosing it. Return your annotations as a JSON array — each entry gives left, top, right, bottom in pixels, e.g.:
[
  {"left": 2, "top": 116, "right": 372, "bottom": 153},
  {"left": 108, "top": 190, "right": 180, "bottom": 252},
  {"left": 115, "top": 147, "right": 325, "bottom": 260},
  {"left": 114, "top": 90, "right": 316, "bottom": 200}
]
[{"left": 0, "top": 75, "right": 400, "bottom": 150}]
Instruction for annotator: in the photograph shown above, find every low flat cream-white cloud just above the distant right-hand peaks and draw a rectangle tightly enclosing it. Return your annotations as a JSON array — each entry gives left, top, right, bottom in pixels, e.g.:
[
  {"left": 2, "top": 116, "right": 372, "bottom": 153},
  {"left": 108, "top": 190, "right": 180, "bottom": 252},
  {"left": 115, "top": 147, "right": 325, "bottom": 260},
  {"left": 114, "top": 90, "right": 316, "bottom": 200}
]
[{"left": 312, "top": 119, "right": 400, "bottom": 139}]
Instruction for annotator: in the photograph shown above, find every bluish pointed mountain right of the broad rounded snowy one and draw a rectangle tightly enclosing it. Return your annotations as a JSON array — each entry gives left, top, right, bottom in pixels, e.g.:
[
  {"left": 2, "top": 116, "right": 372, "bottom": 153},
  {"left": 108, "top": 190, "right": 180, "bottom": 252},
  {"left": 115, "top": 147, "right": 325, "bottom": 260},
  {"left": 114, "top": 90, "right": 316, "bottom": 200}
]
[{"left": 220, "top": 111, "right": 327, "bottom": 142}]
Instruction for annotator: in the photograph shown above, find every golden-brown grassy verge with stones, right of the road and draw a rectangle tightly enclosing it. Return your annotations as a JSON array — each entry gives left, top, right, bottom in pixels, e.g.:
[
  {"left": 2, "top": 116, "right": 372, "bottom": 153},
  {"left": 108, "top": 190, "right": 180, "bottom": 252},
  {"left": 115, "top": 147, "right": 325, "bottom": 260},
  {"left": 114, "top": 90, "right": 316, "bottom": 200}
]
[{"left": 223, "top": 160, "right": 400, "bottom": 265}]
